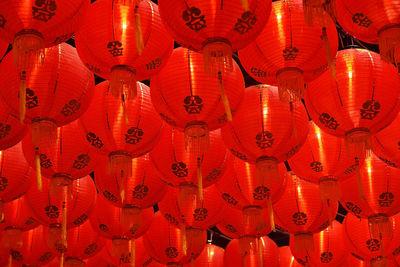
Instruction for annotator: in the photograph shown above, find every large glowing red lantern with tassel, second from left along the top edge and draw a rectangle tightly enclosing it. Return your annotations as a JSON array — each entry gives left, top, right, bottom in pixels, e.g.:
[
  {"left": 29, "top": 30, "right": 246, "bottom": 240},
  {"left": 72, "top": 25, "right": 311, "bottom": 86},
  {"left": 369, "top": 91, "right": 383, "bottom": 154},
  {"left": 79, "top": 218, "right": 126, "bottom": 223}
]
[{"left": 76, "top": 0, "right": 173, "bottom": 99}]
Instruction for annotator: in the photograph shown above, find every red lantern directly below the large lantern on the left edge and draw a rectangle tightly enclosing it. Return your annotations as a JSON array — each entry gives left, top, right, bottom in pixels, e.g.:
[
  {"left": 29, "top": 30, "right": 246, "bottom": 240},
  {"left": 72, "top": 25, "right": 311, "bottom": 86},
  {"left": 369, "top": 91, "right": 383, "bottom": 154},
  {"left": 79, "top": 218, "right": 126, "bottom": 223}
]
[{"left": 22, "top": 121, "right": 98, "bottom": 193}]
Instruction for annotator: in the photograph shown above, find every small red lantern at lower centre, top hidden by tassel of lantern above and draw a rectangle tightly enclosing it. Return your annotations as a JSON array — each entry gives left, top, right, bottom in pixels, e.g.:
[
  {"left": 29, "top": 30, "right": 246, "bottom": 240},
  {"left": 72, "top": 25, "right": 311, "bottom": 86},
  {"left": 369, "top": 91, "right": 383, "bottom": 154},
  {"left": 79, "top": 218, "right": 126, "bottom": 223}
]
[{"left": 157, "top": 185, "right": 223, "bottom": 230}]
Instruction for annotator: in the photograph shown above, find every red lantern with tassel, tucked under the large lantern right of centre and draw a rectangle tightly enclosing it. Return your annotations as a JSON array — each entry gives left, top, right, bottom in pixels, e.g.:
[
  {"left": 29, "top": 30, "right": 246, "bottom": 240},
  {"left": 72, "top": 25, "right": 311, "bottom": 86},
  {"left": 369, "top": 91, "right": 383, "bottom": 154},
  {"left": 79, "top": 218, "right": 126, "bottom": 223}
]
[{"left": 216, "top": 158, "right": 286, "bottom": 233}]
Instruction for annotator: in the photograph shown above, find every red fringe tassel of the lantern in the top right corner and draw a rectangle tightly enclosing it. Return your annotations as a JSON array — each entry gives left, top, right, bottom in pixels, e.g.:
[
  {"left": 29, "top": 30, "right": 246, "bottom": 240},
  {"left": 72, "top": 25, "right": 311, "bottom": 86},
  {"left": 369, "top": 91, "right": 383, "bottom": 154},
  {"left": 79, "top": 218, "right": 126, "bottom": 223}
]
[{"left": 378, "top": 24, "right": 400, "bottom": 64}]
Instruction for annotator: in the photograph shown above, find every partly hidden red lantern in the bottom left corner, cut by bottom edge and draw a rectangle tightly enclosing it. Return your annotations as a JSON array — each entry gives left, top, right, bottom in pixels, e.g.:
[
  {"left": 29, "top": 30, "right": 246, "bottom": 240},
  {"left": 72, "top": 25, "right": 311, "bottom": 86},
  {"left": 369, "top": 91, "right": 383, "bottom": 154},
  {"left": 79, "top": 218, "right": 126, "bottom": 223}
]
[{"left": 4, "top": 225, "right": 55, "bottom": 266}]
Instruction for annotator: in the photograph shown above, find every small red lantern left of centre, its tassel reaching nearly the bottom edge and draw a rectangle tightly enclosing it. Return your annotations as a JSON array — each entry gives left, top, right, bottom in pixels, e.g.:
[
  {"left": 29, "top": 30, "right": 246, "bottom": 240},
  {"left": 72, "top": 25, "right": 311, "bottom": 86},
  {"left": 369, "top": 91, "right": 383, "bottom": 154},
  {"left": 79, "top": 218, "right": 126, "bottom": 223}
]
[{"left": 90, "top": 196, "right": 153, "bottom": 266}]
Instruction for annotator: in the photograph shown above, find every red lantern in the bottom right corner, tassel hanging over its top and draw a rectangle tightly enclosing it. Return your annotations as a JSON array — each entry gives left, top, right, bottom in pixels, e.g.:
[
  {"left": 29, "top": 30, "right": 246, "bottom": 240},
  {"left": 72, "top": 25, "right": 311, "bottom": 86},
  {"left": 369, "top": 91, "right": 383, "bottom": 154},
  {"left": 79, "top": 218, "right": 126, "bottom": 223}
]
[{"left": 343, "top": 214, "right": 400, "bottom": 267}]
